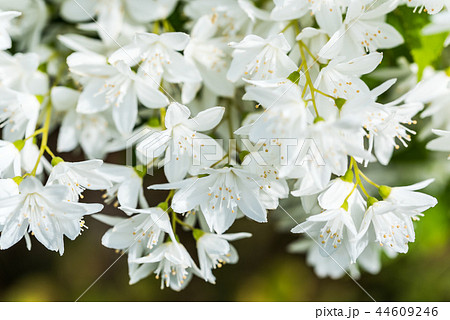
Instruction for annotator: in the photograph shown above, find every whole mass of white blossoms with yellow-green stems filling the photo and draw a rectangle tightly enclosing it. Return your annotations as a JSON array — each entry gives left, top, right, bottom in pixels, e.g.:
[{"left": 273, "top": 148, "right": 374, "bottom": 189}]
[{"left": 0, "top": 0, "right": 450, "bottom": 290}]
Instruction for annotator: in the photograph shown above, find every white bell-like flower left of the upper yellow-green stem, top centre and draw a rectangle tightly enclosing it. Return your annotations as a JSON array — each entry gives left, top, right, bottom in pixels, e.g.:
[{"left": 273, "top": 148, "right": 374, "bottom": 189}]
[{"left": 227, "top": 33, "right": 297, "bottom": 82}]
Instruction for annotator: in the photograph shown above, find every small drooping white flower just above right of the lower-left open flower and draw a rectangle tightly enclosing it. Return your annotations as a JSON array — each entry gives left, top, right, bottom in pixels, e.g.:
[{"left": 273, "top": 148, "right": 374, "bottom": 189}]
[{"left": 47, "top": 159, "right": 112, "bottom": 202}]
